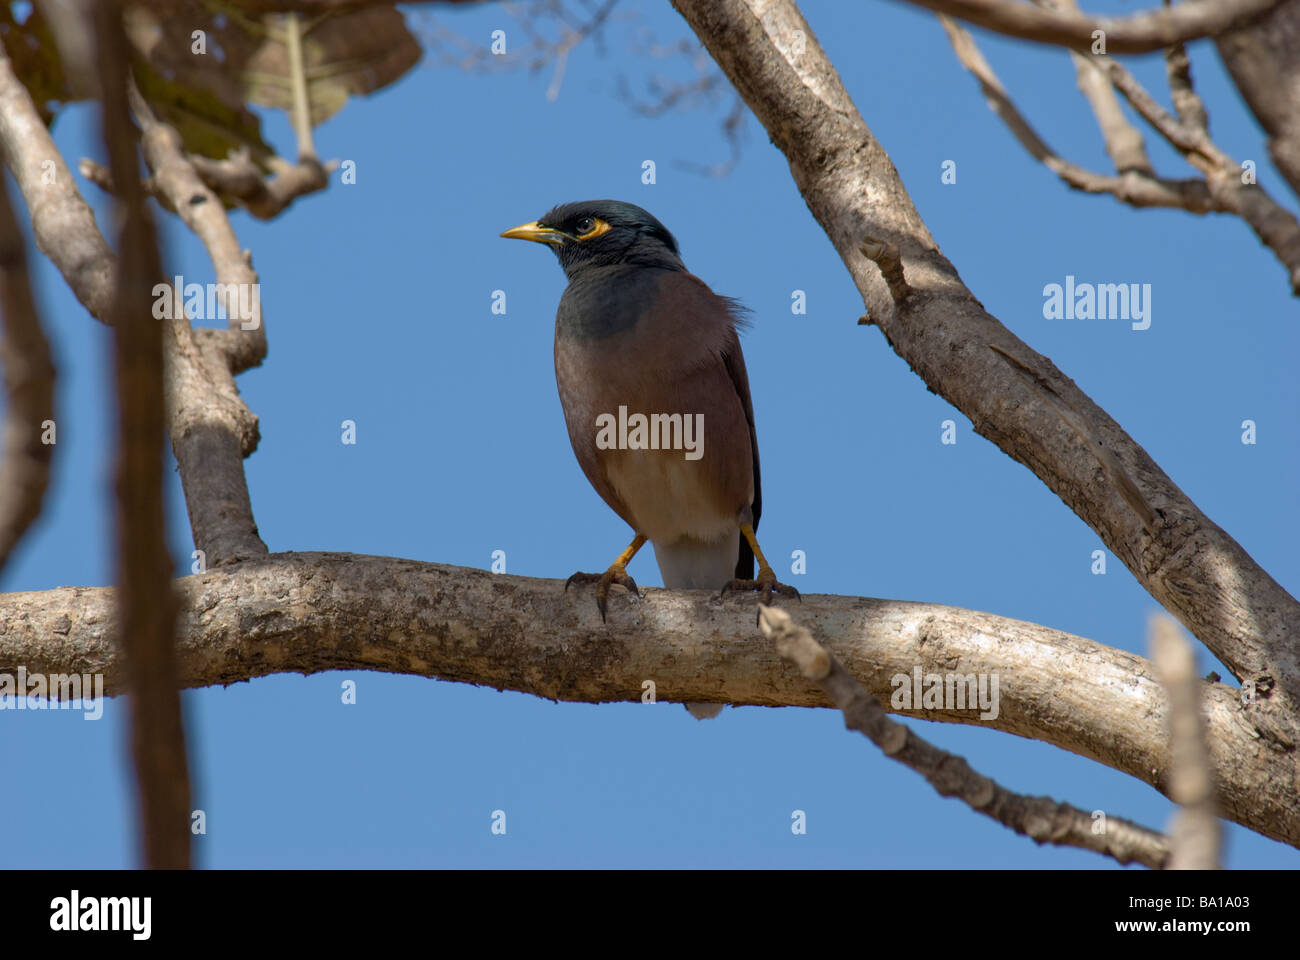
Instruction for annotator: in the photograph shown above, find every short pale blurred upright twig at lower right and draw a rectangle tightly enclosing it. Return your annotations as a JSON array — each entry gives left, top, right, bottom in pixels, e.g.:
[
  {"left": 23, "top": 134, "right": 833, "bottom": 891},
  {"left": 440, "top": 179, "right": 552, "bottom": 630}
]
[{"left": 1151, "top": 615, "right": 1222, "bottom": 870}]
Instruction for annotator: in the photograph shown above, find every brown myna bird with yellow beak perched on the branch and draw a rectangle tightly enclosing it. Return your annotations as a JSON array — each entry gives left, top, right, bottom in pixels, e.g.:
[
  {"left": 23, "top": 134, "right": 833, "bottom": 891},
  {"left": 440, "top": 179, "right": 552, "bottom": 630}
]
[{"left": 502, "top": 200, "right": 798, "bottom": 717}]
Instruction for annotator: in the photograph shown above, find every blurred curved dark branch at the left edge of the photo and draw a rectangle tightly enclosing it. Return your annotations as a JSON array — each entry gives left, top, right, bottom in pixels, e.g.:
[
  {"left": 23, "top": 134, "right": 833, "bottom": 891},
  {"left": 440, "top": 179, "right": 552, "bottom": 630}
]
[{"left": 0, "top": 170, "right": 55, "bottom": 571}]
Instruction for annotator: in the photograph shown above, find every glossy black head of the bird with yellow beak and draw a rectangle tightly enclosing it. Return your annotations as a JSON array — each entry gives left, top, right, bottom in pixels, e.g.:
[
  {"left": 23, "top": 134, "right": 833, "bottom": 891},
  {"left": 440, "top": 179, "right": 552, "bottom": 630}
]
[{"left": 502, "top": 200, "right": 685, "bottom": 277}]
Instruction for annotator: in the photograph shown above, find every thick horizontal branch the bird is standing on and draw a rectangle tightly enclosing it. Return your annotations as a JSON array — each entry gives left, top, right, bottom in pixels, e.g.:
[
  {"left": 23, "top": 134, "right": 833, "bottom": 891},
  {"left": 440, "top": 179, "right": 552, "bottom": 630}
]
[{"left": 0, "top": 553, "right": 1300, "bottom": 846}]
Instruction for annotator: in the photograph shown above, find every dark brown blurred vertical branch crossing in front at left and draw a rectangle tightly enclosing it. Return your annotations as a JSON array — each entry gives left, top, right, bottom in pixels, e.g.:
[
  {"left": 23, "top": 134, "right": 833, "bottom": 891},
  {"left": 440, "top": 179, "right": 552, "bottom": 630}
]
[{"left": 92, "top": 3, "right": 190, "bottom": 868}]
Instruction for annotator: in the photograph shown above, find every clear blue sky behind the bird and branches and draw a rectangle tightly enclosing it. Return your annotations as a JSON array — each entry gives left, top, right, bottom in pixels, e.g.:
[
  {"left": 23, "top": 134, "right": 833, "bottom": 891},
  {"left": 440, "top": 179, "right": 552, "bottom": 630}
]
[{"left": 0, "top": 0, "right": 1300, "bottom": 868}]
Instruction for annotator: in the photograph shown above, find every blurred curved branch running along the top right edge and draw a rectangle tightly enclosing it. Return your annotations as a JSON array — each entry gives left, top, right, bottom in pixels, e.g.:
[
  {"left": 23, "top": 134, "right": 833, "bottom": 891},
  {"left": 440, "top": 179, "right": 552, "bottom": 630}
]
[{"left": 907, "top": 0, "right": 1281, "bottom": 53}]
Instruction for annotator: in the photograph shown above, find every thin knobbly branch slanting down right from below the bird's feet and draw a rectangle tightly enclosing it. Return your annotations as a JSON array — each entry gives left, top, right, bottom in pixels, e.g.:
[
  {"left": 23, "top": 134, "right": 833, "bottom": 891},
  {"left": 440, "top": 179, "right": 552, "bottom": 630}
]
[{"left": 758, "top": 606, "right": 1169, "bottom": 869}]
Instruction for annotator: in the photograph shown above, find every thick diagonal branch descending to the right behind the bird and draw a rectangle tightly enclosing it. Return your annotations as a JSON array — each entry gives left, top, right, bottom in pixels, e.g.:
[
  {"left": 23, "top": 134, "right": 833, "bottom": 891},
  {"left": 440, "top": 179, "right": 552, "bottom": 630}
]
[{"left": 673, "top": 0, "right": 1300, "bottom": 753}]
